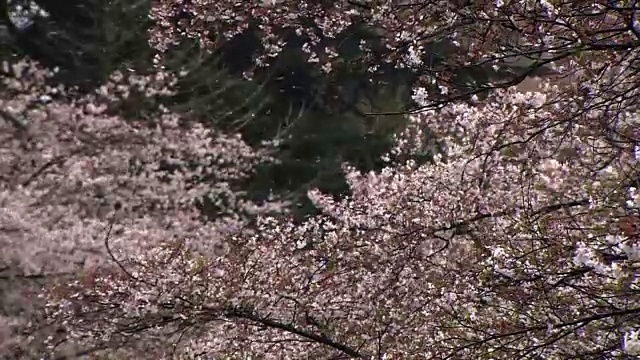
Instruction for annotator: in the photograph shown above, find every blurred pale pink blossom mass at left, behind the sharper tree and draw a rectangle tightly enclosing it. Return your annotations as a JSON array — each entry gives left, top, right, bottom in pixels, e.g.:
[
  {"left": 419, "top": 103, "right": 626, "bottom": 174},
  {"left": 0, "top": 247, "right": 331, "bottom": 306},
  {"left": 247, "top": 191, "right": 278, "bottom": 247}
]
[{"left": 0, "top": 59, "right": 282, "bottom": 271}]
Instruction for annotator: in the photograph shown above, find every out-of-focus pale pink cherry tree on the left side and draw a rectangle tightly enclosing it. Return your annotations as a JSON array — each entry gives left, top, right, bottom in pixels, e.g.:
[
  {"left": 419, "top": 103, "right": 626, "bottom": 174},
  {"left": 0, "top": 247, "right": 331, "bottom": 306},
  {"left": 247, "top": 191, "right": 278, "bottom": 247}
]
[{"left": 0, "top": 60, "right": 281, "bottom": 356}]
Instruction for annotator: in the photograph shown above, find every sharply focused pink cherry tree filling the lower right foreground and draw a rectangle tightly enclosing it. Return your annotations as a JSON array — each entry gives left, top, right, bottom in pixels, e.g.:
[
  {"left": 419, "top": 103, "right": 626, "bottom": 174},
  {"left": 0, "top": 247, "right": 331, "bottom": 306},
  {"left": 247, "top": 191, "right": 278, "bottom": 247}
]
[{"left": 43, "top": 57, "right": 640, "bottom": 359}]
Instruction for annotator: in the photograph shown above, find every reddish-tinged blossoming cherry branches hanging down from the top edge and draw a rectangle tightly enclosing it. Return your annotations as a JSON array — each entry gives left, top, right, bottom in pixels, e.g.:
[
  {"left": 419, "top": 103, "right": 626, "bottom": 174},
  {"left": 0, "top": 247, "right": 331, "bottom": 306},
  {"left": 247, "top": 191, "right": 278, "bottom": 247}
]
[{"left": 150, "top": 0, "right": 640, "bottom": 98}]
